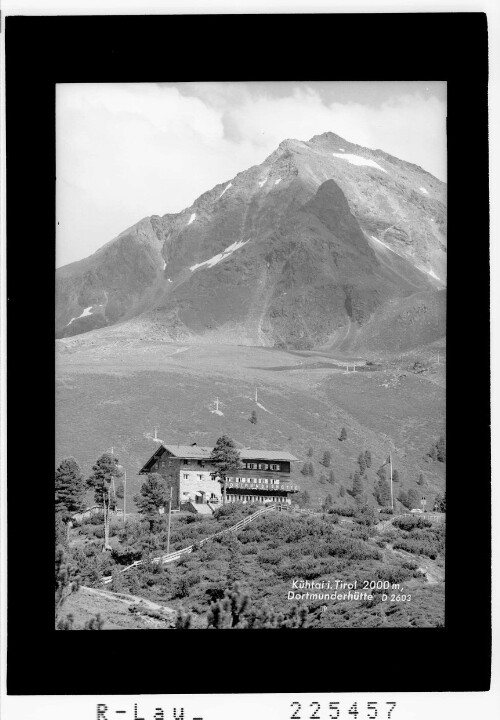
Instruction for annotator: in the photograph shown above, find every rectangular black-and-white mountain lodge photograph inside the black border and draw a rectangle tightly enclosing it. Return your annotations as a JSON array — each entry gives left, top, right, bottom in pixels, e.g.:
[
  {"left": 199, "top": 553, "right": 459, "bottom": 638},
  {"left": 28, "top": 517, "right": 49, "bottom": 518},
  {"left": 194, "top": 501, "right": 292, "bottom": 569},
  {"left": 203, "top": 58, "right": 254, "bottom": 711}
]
[{"left": 55, "top": 80, "right": 447, "bottom": 630}]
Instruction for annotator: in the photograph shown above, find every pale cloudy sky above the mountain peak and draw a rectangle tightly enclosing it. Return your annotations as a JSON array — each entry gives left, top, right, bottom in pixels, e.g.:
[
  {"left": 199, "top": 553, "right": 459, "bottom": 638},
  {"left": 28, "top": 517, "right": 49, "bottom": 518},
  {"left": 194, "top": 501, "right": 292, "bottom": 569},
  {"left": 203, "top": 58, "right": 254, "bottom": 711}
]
[{"left": 56, "top": 81, "right": 446, "bottom": 267}]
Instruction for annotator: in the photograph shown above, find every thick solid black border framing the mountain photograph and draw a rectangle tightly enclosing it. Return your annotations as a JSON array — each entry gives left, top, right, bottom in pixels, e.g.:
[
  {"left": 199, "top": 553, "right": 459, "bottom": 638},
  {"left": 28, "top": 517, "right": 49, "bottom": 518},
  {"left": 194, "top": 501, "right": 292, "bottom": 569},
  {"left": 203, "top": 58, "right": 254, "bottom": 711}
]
[{"left": 5, "top": 13, "right": 491, "bottom": 695}]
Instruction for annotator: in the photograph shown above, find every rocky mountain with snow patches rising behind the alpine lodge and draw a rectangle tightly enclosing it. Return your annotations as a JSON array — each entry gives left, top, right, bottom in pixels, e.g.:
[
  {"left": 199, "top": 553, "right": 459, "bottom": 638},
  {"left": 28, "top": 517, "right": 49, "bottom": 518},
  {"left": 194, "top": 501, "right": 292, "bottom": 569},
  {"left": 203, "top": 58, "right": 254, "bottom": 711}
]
[{"left": 56, "top": 133, "right": 446, "bottom": 349}]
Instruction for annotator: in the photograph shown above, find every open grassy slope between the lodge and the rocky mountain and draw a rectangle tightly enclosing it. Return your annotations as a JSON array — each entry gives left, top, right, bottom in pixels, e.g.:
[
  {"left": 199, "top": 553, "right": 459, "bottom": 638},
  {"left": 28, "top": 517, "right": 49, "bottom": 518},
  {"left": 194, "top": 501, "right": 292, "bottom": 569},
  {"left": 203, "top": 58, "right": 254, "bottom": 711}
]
[{"left": 56, "top": 339, "right": 445, "bottom": 511}]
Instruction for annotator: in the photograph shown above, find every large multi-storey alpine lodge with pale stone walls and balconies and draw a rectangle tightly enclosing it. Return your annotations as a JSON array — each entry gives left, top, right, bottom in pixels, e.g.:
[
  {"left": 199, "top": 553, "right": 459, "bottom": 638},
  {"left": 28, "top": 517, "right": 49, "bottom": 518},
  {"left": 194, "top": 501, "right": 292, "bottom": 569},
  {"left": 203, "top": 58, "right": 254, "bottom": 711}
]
[{"left": 139, "top": 444, "right": 299, "bottom": 509}]
